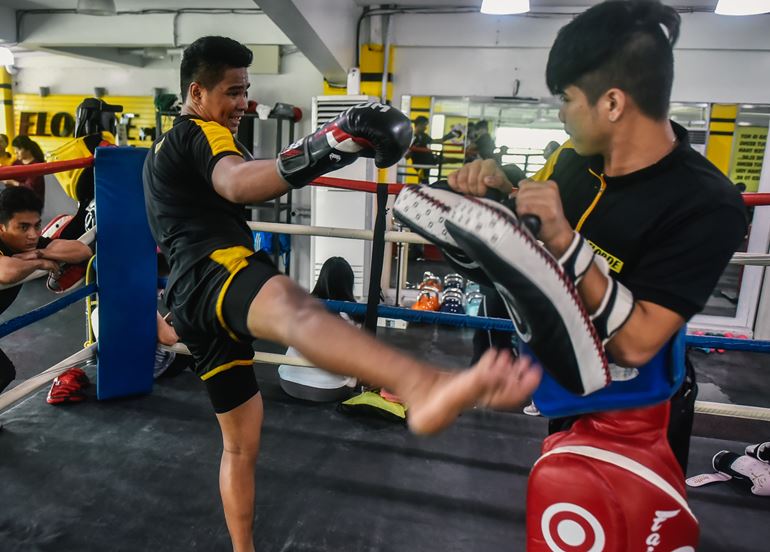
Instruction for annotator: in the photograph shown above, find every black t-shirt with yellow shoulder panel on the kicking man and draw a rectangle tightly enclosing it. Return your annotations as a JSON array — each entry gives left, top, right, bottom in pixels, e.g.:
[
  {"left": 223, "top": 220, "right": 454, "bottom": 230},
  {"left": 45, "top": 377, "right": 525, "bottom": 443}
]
[{"left": 143, "top": 115, "right": 254, "bottom": 293}]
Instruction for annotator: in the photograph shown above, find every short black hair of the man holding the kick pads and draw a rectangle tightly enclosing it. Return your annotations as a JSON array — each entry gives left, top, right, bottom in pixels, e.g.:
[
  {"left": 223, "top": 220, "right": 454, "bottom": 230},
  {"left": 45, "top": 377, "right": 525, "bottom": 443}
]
[{"left": 545, "top": 0, "right": 681, "bottom": 120}]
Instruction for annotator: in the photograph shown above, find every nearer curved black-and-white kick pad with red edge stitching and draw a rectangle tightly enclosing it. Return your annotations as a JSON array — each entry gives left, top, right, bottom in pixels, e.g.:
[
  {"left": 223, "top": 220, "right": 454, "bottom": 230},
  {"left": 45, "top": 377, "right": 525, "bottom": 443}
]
[{"left": 445, "top": 198, "right": 610, "bottom": 395}]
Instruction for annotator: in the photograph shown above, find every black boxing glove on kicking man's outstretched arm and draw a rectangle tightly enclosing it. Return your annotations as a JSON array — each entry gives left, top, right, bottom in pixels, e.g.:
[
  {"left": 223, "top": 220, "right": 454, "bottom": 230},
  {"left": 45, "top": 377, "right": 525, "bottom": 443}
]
[{"left": 276, "top": 102, "right": 412, "bottom": 188}]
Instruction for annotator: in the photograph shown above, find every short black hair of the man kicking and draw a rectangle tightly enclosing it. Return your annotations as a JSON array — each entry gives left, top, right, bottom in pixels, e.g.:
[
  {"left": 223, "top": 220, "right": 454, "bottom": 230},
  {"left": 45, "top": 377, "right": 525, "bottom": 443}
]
[{"left": 179, "top": 36, "right": 254, "bottom": 101}]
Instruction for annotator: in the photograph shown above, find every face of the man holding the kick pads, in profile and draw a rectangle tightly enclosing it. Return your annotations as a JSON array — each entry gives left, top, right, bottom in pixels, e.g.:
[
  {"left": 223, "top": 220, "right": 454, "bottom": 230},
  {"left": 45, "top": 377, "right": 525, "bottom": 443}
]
[{"left": 559, "top": 85, "right": 607, "bottom": 155}]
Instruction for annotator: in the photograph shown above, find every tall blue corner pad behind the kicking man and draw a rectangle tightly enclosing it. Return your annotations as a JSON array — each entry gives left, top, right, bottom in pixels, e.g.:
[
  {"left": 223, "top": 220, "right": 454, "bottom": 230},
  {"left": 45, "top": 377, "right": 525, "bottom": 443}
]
[{"left": 94, "top": 147, "right": 158, "bottom": 399}]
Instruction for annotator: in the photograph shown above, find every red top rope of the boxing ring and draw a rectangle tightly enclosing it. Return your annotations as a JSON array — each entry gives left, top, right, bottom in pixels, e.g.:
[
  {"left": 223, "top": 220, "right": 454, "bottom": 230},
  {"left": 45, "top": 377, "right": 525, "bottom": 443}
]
[{"left": 0, "top": 157, "right": 770, "bottom": 207}]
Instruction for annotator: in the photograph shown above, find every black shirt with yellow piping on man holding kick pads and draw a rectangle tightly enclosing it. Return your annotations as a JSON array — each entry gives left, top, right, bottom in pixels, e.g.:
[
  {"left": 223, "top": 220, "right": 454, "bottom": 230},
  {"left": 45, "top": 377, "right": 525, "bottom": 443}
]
[{"left": 534, "top": 123, "right": 746, "bottom": 319}]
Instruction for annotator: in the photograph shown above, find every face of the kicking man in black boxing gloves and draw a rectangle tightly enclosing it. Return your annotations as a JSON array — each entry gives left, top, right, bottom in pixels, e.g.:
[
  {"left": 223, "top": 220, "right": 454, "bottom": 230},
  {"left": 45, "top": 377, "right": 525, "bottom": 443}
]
[{"left": 198, "top": 67, "right": 249, "bottom": 134}]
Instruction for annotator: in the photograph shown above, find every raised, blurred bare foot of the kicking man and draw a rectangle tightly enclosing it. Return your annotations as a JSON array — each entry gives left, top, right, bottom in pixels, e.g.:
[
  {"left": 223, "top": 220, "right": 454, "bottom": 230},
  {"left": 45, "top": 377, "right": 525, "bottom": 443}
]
[{"left": 402, "top": 349, "right": 540, "bottom": 433}]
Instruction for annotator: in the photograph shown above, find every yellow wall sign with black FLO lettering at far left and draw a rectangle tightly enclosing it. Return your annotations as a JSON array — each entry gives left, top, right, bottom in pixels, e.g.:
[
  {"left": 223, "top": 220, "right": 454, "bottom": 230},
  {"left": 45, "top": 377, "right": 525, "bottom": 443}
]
[{"left": 13, "top": 94, "right": 155, "bottom": 153}]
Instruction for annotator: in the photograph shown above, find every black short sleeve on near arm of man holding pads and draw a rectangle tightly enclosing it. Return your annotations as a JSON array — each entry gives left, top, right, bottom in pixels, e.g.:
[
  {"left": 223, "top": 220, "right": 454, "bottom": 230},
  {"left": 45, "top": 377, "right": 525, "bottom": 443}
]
[{"left": 624, "top": 207, "right": 746, "bottom": 320}]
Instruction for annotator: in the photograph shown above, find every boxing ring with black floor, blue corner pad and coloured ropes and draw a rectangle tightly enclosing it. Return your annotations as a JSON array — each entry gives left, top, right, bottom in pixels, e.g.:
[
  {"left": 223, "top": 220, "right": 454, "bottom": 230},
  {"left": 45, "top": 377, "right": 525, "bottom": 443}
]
[{"left": 0, "top": 148, "right": 770, "bottom": 552}]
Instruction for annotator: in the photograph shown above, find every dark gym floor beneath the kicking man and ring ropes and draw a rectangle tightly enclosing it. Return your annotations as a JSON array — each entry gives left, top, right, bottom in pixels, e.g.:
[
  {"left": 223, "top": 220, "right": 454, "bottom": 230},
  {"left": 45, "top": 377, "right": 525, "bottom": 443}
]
[{"left": 0, "top": 274, "right": 770, "bottom": 552}]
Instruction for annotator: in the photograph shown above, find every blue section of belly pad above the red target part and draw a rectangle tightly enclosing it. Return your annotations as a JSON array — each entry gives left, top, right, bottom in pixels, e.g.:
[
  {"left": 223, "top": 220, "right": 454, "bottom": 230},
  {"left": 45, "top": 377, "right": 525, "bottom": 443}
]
[{"left": 520, "top": 328, "right": 685, "bottom": 418}]
